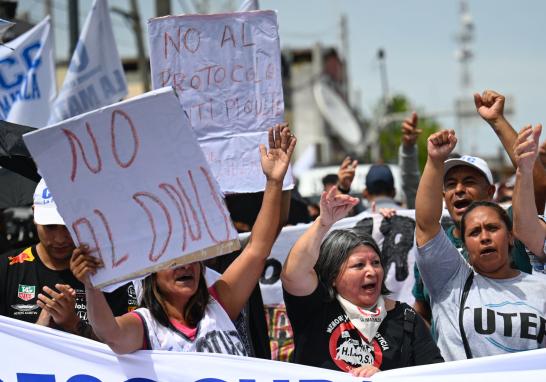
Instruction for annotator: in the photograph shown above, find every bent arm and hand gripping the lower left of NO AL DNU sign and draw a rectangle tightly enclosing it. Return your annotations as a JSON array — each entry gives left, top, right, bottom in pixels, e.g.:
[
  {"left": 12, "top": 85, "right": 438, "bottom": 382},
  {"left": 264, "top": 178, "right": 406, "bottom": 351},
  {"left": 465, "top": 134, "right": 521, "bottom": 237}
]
[{"left": 70, "top": 245, "right": 144, "bottom": 354}]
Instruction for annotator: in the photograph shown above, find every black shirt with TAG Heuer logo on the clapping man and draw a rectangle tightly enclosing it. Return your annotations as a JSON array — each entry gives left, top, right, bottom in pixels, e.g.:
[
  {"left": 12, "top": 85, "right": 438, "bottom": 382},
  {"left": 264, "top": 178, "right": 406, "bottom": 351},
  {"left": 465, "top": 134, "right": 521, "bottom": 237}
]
[{"left": 0, "top": 246, "right": 137, "bottom": 323}]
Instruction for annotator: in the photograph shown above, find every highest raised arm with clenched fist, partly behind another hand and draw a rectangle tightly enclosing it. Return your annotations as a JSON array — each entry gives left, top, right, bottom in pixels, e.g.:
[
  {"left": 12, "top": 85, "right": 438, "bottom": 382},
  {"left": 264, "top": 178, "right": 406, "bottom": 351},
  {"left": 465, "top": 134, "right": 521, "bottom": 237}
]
[{"left": 474, "top": 90, "right": 546, "bottom": 213}]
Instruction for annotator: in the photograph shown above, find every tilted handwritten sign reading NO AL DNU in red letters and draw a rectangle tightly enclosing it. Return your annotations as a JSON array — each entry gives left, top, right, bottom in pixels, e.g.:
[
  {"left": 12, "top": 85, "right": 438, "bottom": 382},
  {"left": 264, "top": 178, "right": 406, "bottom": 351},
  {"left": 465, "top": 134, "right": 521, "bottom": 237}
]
[{"left": 24, "top": 88, "right": 239, "bottom": 287}]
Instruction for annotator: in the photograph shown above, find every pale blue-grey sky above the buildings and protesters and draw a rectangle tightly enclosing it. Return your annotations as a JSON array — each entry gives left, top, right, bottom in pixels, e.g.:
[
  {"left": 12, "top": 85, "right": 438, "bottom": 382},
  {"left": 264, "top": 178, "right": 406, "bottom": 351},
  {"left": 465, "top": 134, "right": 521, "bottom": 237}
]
[{"left": 19, "top": 0, "right": 546, "bottom": 155}]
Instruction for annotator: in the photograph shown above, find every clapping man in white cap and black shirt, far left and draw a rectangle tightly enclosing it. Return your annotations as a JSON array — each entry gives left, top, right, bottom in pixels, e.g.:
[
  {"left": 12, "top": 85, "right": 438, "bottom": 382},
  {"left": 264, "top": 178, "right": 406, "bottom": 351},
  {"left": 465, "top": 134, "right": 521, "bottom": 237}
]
[{"left": 0, "top": 179, "right": 136, "bottom": 337}]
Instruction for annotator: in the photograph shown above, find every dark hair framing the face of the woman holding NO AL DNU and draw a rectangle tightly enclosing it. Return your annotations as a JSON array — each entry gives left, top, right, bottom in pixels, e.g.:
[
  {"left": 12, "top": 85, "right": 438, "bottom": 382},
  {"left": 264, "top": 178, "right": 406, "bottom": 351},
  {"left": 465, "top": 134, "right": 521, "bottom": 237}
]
[{"left": 140, "top": 264, "right": 210, "bottom": 328}]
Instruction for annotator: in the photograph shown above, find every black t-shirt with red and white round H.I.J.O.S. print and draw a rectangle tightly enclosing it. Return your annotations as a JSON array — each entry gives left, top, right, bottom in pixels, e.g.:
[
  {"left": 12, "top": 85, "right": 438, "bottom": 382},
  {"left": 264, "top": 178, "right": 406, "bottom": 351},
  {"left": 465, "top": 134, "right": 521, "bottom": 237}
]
[{"left": 284, "top": 283, "right": 443, "bottom": 371}]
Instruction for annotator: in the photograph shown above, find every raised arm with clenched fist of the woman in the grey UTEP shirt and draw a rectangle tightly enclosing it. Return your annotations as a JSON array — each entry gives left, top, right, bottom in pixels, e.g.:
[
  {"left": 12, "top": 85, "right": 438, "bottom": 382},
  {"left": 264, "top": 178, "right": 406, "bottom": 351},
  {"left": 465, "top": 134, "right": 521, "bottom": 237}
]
[{"left": 415, "top": 130, "right": 457, "bottom": 246}]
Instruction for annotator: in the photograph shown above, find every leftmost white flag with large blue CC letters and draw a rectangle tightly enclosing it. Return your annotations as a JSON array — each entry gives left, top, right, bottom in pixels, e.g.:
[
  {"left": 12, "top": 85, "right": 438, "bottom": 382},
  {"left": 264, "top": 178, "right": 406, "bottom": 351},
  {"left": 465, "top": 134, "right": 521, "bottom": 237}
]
[{"left": 0, "top": 17, "right": 56, "bottom": 128}]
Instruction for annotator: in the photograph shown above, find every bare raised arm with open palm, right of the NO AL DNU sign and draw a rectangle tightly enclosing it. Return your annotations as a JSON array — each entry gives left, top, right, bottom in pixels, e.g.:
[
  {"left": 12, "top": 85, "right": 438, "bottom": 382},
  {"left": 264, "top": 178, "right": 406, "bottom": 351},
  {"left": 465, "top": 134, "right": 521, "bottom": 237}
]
[{"left": 215, "top": 125, "right": 296, "bottom": 320}]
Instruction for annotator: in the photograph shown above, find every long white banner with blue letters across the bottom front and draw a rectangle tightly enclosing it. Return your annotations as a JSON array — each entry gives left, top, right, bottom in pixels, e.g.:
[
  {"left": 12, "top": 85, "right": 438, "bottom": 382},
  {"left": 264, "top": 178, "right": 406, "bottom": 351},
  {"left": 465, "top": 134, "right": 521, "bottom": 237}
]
[{"left": 0, "top": 316, "right": 546, "bottom": 382}]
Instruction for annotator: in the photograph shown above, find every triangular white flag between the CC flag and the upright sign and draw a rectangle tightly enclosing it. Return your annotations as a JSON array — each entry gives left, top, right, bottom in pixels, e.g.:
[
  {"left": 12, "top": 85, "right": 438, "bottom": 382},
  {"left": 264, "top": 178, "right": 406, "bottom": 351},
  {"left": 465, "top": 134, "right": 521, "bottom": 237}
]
[{"left": 49, "top": 0, "right": 127, "bottom": 124}]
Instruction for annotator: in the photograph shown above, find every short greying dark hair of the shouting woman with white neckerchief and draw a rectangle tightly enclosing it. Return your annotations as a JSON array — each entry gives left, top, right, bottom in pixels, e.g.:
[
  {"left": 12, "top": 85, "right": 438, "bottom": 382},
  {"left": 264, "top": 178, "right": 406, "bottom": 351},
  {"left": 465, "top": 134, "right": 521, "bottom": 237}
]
[{"left": 315, "top": 229, "right": 390, "bottom": 300}]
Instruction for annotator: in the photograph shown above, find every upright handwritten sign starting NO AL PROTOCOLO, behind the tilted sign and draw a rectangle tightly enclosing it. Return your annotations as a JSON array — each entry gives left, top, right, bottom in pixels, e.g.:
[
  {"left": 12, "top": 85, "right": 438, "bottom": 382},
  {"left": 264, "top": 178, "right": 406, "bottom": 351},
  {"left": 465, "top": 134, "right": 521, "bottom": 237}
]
[{"left": 148, "top": 11, "right": 293, "bottom": 193}]
